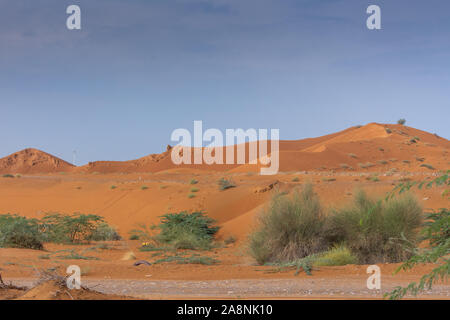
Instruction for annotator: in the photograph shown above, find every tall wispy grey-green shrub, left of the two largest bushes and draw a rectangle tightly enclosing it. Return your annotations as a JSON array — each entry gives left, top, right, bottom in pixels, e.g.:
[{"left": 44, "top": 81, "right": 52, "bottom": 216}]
[{"left": 249, "top": 184, "right": 328, "bottom": 264}]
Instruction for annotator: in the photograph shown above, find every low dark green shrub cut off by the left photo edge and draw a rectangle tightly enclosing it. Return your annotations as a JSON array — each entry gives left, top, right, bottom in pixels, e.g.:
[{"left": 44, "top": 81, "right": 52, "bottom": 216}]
[{"left": 0, "top": 214, "right": 43, "bottom": 250}]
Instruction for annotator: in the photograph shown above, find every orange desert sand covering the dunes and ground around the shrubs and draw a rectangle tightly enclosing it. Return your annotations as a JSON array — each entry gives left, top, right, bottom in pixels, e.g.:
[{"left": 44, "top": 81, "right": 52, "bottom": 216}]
[{"left": 0, "top": 123, "right": 450, "bottom": 299}]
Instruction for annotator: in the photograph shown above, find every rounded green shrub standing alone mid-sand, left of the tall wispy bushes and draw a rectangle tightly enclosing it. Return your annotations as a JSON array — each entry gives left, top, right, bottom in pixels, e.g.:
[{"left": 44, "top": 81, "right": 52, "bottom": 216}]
[{"left": 155, "top": 211, "right": 219, "bottom": 249}]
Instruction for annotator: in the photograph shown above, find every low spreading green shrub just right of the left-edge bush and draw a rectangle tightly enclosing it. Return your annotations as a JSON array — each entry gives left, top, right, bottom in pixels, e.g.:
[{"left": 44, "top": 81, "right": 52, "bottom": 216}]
[{"left": 41, "top": 213, "right": 104, "bottom": 243}]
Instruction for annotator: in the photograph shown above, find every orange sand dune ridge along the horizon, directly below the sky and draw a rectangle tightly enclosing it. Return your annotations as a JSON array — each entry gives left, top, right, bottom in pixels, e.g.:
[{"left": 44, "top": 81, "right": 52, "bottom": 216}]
[{"left": 0, "top": 123, "right": 450, "bottom": 173}]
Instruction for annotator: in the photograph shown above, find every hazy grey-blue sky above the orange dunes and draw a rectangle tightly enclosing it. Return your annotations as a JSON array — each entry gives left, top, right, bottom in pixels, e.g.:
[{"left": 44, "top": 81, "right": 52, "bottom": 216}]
[{"left": 0, "top": 0, "right": 450, "bottom": 165}]
